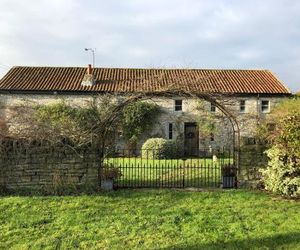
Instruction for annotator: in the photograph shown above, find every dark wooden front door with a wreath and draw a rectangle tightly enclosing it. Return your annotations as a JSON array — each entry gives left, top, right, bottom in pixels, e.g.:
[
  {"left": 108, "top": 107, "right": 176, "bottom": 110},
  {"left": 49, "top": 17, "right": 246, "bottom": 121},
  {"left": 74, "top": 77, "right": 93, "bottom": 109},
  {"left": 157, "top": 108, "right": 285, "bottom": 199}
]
[{"left": 184, "top": 122, "right": 199, "bottom": 156}]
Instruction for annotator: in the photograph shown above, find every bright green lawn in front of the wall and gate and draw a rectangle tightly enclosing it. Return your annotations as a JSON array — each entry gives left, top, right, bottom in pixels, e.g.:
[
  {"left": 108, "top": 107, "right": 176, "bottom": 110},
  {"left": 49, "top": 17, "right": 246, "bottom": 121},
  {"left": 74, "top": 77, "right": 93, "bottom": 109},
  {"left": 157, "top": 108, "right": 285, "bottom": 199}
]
[{"left": 0, "top": 190, "right": 300, "bottom": 249}]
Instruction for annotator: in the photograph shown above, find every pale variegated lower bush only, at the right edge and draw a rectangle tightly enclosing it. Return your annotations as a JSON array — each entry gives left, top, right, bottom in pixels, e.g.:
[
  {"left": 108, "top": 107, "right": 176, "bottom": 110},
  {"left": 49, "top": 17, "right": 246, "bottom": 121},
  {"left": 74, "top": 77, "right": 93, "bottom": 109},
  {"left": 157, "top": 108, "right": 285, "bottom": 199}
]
[{"left": 261, "top": 146, "right": 300, "bottom": 197}]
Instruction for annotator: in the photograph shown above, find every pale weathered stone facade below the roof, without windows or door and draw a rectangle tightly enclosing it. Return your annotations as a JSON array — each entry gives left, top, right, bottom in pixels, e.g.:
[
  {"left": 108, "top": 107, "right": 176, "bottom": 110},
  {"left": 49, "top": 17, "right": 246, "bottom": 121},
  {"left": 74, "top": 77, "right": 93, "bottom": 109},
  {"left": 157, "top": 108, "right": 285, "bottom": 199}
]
[{"left": 0, "top": 94, "right": 283, "bottom": 151}]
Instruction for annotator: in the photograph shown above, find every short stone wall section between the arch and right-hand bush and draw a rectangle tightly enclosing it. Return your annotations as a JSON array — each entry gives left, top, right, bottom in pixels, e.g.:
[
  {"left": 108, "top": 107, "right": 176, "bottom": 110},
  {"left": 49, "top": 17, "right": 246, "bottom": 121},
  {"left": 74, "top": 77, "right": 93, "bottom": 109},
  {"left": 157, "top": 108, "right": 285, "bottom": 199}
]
[{"left": 238, "top": 137, "right": 268, "bottom": 188}]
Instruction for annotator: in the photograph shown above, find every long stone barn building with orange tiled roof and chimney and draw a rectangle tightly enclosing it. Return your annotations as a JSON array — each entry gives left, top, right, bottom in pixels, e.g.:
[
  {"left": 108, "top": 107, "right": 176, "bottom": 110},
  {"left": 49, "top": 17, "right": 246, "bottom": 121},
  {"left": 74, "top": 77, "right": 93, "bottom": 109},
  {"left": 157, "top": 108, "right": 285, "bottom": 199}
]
[{"left": 0, "top": 66, "right": 291, "bottom": 155}]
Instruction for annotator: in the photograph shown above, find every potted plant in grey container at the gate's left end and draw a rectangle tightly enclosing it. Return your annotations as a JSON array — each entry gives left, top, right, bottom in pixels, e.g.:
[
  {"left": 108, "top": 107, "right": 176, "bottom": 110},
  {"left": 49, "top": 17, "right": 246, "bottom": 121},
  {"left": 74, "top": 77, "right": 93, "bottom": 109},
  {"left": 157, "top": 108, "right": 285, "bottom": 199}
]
[{"left": 100, "top": 163, "right": 121, "bottom": 191}]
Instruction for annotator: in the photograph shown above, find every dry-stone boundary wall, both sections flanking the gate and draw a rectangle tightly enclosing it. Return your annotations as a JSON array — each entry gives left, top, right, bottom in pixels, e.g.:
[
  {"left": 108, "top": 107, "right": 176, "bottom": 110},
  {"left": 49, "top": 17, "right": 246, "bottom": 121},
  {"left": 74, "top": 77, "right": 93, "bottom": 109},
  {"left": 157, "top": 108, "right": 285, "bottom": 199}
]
[{"left": 0, "top": 137, "right": 267, "bottom": 189}]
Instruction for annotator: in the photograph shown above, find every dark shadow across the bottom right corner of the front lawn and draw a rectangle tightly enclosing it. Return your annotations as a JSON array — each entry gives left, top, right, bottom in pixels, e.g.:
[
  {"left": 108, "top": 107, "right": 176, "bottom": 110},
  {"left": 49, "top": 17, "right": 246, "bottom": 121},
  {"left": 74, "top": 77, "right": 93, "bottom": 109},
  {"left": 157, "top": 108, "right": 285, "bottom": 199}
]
[{"left": 164, "top": 232, "right": 300, "bottom": 250}]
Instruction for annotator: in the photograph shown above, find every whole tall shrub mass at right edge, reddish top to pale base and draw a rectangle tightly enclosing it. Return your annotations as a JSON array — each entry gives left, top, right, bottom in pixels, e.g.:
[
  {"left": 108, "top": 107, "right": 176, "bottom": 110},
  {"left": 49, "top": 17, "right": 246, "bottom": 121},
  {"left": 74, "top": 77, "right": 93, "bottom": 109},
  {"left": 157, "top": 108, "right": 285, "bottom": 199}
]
[{"left": 261, "top": 109, "right": 300, "bottom": 197}]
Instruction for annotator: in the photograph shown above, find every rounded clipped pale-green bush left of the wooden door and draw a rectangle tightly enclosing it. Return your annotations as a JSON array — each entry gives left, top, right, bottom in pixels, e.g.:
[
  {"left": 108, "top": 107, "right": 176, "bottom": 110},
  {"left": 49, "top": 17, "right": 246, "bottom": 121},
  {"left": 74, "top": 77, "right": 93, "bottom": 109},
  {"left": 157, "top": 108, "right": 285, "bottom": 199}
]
[{"left": 142, "top": 138, "right": 178, "bottom": 159}]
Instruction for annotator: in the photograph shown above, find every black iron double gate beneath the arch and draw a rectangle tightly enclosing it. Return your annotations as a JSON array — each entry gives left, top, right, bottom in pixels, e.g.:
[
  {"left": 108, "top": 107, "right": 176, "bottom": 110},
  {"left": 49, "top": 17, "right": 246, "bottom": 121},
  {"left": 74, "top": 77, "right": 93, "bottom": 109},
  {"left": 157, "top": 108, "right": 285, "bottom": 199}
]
[{"left": 102, "top": 148, "right": 236, "bottom": 188}]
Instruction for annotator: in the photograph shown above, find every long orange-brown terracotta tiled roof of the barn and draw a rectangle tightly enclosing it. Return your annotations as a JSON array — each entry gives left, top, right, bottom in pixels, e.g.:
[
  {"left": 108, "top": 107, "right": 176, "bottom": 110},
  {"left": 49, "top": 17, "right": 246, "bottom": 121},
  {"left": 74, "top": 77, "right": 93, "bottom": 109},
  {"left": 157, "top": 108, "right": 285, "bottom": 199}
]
[{"left": 0, "top": 66, "right": 290, "bottom": 94}]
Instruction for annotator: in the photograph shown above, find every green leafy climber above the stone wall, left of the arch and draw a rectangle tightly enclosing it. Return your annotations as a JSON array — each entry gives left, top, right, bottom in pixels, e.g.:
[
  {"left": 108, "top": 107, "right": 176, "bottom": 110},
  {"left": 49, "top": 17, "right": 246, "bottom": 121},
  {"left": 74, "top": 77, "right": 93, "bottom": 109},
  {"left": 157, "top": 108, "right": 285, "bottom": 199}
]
[{"left": 34, "top": 98, "right": 117, "bottom": 145}]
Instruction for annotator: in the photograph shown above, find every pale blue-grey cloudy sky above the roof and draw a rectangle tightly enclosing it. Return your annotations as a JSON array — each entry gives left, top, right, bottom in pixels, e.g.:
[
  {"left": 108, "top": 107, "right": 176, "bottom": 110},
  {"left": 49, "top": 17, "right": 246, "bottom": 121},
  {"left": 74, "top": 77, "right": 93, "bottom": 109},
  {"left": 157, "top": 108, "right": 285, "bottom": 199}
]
[{"left": 0, "top": 0, "right": 300, "bottom": 91}]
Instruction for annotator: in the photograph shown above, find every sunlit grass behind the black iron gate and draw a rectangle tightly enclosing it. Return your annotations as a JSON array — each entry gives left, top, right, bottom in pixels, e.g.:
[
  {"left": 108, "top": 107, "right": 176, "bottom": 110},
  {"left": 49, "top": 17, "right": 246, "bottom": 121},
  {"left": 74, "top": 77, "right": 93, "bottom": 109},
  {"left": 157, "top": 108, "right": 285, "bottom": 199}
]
[{"left": 105, "top": 157, "right": 233, "bottom": 187}]
